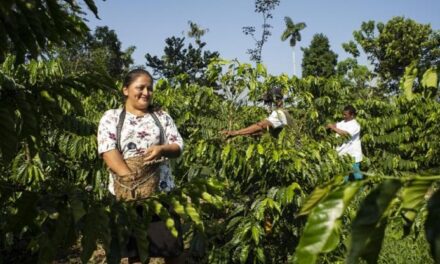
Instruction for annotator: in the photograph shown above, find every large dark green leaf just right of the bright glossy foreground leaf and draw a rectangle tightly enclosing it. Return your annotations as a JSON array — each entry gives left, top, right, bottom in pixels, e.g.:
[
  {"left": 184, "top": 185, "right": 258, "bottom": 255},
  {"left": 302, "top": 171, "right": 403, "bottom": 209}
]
[{"left": 347, "top": 180, "right": 401, "bottom": 263}]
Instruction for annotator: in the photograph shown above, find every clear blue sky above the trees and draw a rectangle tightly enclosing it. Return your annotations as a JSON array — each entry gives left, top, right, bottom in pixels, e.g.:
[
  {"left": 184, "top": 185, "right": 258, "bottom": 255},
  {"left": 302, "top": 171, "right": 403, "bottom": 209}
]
[{"left": 86, "top": 0, "right": 440, "bottom": 75}]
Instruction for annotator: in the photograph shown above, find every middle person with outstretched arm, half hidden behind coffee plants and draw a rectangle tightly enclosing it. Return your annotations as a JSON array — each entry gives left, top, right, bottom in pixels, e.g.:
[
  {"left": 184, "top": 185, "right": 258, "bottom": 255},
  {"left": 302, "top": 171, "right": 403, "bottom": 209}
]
[{"left": 221, "top": 87, "right": 293, "bottom": 137}]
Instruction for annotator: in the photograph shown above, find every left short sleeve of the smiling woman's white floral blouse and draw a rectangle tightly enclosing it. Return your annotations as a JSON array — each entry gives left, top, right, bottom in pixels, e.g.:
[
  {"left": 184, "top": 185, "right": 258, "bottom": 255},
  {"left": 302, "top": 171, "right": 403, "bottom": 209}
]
[{"left": 98, "top": 110, "right": 118, "bottom": 154}]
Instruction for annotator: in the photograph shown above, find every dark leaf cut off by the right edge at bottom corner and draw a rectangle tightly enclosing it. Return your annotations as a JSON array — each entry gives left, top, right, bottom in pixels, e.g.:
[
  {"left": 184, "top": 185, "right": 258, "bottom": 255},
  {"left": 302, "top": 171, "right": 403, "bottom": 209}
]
[{"left": 425, "top": 190, "right": 440, "bottom": 263}]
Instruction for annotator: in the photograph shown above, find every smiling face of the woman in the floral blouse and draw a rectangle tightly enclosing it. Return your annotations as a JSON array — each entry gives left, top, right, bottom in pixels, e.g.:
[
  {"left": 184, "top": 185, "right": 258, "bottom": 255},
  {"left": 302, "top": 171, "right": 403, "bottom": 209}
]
[{"left": 122, "top": 74, "right": 153, "bottom": 110}]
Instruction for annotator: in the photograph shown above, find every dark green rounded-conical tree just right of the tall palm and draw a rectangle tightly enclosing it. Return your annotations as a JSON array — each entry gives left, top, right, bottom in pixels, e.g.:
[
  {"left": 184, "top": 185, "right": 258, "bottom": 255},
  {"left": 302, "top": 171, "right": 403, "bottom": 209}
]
[{"left": 302, "top": 34, "right": 338, "bottom": 78}]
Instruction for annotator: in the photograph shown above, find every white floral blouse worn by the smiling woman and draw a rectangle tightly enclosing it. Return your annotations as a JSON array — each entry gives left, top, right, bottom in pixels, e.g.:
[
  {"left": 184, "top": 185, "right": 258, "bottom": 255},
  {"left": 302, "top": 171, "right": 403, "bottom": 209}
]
[{"left": 98, "top": 109, "right": 183, "bottom": 194}]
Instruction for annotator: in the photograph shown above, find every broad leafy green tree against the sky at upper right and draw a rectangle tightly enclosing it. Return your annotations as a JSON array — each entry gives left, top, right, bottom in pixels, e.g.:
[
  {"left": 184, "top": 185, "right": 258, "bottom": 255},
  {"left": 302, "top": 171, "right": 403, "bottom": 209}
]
[{"left": 353, "top": 17, "right": 440, "bottom": 91}]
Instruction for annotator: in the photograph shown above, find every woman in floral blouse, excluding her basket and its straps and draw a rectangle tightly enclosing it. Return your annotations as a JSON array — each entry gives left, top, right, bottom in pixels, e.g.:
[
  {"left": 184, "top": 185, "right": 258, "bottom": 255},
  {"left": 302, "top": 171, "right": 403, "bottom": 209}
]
[{"left": 98, "top": 69, "right": 183, "bottom": 263}]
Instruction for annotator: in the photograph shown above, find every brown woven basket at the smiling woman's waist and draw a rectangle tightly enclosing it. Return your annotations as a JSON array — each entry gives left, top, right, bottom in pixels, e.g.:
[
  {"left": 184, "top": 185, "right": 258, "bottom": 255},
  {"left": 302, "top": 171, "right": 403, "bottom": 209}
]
[{"left": 113, "top": 156, "right": 165, "bottom": 201}]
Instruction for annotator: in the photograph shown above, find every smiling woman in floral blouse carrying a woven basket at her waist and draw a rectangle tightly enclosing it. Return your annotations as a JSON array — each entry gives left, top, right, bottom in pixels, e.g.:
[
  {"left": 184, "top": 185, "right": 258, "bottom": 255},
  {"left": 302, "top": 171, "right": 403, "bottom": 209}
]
[{"left": 98, "top": 69, "right": 183, "bottom": 263}]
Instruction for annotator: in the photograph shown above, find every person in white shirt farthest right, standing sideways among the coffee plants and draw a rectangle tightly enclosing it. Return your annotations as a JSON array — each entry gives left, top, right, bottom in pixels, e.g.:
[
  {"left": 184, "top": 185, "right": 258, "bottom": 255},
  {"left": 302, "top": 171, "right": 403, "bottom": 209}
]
[{"left": 327, "top": 105, "right": 363, "bottom": 180}]
